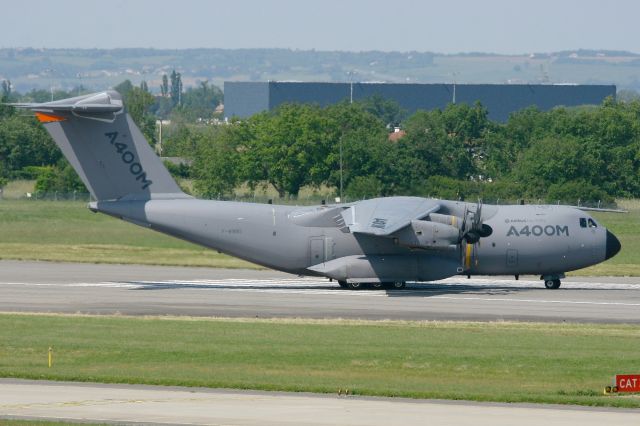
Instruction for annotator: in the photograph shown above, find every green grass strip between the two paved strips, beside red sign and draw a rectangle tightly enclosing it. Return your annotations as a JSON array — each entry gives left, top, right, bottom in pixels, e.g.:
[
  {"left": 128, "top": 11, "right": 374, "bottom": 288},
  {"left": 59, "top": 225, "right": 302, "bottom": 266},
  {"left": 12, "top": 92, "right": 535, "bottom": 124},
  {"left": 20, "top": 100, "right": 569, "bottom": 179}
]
[{"left": 0, "top": 314, "right": 640, "bottom": 407}]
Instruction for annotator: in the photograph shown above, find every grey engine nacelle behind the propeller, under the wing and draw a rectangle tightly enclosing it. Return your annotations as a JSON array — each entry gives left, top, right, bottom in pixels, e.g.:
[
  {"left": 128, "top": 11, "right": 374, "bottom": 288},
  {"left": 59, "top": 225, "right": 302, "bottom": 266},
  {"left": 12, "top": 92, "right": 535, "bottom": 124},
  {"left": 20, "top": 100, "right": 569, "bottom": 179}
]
[{"left": 394, "top": 220, "right": 460, "bottom": 248}]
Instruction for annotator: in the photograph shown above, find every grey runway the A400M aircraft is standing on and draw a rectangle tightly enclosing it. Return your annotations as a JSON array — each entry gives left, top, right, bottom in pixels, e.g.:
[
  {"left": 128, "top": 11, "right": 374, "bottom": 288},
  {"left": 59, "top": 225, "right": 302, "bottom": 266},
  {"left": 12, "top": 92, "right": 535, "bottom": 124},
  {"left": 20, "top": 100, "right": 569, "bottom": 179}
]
[{"left": 0, "top": 261, "right": 640, "bottom": 323}]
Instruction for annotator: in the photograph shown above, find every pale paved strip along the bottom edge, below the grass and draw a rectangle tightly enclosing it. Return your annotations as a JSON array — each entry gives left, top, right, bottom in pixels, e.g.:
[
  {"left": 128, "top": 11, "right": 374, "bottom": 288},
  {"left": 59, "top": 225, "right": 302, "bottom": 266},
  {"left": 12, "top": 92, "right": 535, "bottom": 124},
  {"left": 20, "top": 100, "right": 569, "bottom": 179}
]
[{"left": 0, "top": 379, "right": 638, "bottom": 426}]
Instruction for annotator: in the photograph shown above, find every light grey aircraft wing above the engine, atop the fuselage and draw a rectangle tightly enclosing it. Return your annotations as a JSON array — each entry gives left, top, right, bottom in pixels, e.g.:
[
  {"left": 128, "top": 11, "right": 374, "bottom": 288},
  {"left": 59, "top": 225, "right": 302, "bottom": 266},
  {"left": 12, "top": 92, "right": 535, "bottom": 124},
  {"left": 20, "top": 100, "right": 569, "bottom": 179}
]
[{"left": 342, "top": 197, "right": 441, "bottom": 236}]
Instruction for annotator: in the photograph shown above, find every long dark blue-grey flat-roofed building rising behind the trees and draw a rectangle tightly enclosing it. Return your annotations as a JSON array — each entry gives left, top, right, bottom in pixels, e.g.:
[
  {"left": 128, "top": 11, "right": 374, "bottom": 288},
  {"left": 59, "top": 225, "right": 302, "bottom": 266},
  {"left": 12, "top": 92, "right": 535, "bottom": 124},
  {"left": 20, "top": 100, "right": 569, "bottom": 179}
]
[{"left": 224, "top": 81, "right": 616, "bottom": 121}]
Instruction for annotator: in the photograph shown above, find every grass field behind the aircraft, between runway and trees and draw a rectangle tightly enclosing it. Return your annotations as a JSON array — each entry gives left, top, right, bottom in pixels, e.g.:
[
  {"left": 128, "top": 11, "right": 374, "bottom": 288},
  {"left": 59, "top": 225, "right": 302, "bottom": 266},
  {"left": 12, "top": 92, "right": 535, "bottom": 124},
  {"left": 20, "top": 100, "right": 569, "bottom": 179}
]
[{"left": 0, "top": 200, "right": 640, "bottom": 276}]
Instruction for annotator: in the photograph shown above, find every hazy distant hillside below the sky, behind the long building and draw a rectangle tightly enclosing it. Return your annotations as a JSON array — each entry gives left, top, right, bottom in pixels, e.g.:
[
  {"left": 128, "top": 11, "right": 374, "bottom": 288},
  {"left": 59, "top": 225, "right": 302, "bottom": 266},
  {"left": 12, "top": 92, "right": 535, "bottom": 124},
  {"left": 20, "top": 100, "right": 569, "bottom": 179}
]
[{"left": 0, "top": 48, "right": 640, "bottom": 92}]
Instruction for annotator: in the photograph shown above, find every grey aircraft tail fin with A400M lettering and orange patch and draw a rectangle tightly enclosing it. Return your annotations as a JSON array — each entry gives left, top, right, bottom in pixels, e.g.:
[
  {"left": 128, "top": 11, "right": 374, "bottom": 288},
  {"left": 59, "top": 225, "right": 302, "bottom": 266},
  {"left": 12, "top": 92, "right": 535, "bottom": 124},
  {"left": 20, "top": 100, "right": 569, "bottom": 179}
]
[{"left": 13, "top": 91, "right": 189, "bottom": 201}]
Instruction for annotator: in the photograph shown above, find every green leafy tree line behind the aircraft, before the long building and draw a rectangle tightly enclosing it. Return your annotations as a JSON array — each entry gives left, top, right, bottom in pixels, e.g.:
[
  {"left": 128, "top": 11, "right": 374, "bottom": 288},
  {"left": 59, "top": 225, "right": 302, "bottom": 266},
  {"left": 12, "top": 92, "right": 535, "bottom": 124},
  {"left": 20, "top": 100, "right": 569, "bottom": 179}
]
[{"left": 0, "top": 75, "right": 640, "bottom": 203}]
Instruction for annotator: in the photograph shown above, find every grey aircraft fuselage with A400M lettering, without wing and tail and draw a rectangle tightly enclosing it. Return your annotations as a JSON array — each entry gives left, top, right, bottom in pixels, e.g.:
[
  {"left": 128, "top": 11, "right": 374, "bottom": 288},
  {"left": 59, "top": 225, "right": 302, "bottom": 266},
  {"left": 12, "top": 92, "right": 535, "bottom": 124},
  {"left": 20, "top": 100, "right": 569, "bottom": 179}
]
[{"left": 92, "top": 197, "right": 615, "bottom": 282}]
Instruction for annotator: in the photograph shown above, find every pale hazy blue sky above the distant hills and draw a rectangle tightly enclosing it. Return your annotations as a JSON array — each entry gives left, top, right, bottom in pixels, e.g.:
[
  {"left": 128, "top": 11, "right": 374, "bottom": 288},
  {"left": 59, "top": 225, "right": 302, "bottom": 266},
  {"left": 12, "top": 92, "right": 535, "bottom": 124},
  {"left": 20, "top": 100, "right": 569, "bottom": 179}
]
[{"left": 0, "top": 0, "right": 640, "bottom": 54}]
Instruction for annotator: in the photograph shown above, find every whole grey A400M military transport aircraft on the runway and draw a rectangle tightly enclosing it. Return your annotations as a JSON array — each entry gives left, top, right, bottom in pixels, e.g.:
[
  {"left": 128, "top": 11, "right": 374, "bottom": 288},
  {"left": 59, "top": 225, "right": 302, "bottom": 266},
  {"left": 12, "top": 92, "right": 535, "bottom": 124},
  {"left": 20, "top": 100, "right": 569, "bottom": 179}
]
[{"left": 15, "top": 91, "right": 620, "bottom": 289}]
